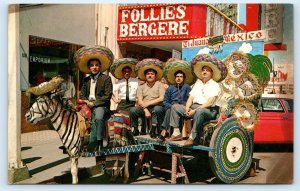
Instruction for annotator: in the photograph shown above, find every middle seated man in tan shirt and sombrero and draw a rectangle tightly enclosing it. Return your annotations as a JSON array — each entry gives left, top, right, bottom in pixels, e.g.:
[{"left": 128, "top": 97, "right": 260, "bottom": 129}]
[{"left": 129, "top": 58, "right": 165, "bottom": 138}]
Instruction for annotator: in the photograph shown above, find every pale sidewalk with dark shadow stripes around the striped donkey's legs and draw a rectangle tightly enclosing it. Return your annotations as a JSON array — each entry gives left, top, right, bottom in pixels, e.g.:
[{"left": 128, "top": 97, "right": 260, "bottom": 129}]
[{"left": 15, "top": 130, "right": 101, "bottom": 184}]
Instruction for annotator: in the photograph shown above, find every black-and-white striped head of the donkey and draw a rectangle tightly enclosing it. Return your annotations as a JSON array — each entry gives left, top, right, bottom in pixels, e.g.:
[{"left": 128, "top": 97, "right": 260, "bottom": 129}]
[{"left": 25, "top": 95, "right": 55, "bottom": 124}]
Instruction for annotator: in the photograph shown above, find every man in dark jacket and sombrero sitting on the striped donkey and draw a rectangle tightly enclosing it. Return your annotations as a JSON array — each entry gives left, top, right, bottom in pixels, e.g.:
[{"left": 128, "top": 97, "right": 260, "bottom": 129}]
[{"left": 74, "top": 46, "right": 114, "bottom": 152}]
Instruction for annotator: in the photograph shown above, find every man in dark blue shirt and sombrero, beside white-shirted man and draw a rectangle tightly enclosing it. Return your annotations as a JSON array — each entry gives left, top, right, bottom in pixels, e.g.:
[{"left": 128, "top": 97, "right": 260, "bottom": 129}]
[{"left": 159, "top": 58, "right": 195, "bottom": 141}]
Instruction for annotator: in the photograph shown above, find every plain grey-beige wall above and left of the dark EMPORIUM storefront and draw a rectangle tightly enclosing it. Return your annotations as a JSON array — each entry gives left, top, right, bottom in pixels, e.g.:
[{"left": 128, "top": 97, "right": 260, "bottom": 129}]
[{"left": 19, "top": 4, "right": 96, "bottom": 90}]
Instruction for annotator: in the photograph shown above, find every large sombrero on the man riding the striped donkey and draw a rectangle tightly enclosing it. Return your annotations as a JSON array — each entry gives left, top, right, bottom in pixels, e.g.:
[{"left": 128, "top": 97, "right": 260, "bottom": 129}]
[{"left": 74, "top": 45, "right": 114, "bottom": 74}]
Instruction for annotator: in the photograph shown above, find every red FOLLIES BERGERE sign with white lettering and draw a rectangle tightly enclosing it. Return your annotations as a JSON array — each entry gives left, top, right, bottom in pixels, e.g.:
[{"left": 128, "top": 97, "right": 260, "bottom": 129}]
[{"left": 118, "top": 4, "right": 206, "bottom": 42}]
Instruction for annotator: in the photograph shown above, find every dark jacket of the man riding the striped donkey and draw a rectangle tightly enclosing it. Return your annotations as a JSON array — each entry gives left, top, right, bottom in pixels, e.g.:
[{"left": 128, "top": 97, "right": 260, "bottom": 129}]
[{"left": 80, "top": 73, "right": 113, "bottom": 109}]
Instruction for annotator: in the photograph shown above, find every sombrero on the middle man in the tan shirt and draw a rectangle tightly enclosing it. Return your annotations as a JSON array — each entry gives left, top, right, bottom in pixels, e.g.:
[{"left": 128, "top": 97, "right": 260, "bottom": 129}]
[{"left": 135, "top": 58, "right": 163, "bottom": 81}]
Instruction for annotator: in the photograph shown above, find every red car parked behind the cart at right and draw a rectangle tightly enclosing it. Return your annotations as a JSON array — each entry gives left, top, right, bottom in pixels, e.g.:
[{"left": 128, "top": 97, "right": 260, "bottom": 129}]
[{"left": 254, "top": 94, "right": 294, "bottom": 144}]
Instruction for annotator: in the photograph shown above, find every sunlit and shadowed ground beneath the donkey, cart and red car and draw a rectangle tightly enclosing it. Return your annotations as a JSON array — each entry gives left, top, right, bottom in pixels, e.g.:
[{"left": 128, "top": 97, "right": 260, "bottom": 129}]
[{"left": 15, "top": 130, "right": 293, "bottom": 184}]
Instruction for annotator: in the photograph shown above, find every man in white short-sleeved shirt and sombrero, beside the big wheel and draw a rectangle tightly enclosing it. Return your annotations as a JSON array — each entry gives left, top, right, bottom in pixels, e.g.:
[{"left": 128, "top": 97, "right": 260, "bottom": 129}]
[{"left": 169, "top": 54, "right": 227, "bottom": 145}]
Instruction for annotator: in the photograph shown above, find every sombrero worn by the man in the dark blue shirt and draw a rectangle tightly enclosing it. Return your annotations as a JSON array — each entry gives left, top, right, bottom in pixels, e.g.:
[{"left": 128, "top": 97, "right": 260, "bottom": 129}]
[{"left": 164, "top": 58, "right": 196, "bottom": 85}]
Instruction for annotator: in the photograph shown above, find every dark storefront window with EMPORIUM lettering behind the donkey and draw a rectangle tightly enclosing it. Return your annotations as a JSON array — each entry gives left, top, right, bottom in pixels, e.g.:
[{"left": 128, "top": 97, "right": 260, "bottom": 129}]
[{"left": 29, "top": 35, "right": 82, "bottom": 86}]
